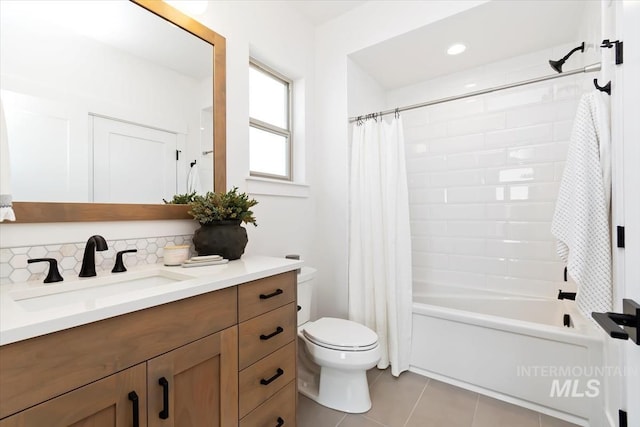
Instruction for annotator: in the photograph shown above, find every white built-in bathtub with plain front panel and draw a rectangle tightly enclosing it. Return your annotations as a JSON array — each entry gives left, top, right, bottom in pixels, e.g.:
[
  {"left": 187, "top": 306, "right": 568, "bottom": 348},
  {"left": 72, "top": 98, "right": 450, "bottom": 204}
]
[{"left": 410, "top": 285, "right": 606, "bottom": 427}]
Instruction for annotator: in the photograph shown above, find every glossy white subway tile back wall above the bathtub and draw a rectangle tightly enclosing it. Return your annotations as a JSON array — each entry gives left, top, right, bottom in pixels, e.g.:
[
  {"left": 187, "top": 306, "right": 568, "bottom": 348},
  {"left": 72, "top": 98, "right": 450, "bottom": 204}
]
[{"left": 396, "top": 46, "right": 592, "bottom": 297}]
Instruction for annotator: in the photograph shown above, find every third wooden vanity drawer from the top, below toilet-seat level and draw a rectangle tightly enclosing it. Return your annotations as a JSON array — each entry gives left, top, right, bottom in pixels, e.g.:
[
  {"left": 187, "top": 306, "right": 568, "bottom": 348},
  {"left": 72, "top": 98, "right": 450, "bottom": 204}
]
[{"left": 238, "top": 342, "right": 296, "bottom": 417}]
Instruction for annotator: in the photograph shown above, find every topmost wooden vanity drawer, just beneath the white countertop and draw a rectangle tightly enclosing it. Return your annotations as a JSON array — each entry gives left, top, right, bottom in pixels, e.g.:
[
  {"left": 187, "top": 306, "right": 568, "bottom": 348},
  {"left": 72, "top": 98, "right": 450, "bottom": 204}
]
[{"left": 238, "top": 271, "right": 296, "bottom": 322}]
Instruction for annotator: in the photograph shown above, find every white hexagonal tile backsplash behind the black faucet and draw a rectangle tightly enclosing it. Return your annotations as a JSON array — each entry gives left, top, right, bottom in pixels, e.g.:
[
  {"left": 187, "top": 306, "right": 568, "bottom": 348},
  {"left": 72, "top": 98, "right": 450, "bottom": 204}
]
[{"left": 0, "top": 234, "right": 195, "bottom": 284}]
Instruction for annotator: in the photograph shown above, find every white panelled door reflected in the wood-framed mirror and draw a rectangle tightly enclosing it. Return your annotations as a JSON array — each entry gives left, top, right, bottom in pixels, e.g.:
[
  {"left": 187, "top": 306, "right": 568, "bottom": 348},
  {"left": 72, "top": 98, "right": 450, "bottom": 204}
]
[{"left": 91, "top": 116, "right": 180, "bottom": 204}]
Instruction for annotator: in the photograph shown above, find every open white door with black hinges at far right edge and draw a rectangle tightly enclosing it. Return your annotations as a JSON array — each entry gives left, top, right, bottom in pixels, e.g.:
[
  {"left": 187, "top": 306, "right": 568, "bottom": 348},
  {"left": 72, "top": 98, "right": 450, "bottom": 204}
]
[{"left": 604, "top": 0, "right": 640, "bottom": 427}]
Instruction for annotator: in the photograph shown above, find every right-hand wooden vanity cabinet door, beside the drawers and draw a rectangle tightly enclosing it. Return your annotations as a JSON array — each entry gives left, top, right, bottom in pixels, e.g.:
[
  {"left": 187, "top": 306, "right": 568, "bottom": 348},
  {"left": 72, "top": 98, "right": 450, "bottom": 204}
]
[{"left": 147, "top": 326, "right": 238, "bottom": 427}]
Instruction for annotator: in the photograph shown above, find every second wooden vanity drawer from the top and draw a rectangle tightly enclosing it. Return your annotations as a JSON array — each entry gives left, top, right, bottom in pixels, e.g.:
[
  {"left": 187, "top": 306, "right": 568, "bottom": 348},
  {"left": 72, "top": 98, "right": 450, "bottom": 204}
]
[{"left": 238, "top": 303, "right": 297, "bottom": 369}]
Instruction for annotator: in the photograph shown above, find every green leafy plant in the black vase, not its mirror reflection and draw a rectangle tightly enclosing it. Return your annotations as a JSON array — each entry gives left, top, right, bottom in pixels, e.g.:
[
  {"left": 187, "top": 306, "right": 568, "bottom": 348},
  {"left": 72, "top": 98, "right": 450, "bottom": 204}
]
[{"left": 189, "top": 187, "right": 258, "bottom": 226}]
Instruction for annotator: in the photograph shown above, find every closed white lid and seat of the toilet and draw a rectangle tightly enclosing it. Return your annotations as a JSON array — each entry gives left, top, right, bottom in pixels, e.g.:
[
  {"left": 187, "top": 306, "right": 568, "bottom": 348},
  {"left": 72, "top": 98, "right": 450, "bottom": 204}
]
[{"left": 303, "top": 317, "right": 378, "bottom": 351}]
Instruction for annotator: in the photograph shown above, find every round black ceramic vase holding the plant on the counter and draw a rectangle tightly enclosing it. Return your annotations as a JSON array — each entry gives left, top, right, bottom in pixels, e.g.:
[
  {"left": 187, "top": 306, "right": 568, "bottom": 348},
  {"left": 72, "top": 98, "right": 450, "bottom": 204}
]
[{"left": 193, "top": 220, "right": 249, "bottom": 260}]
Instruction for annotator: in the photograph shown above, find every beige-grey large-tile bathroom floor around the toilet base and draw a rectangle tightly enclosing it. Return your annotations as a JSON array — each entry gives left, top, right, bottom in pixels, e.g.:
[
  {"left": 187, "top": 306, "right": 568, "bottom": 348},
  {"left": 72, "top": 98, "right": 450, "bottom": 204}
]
[{"left": 298, "top": 368, "right": 576, "bottom": 427}]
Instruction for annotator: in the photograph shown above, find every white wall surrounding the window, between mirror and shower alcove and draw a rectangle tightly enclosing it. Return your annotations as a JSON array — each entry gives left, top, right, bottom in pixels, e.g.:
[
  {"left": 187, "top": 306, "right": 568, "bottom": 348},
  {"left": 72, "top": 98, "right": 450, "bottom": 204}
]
[{"left": 203, "top": 1, "right": 315, "bottom": 265}]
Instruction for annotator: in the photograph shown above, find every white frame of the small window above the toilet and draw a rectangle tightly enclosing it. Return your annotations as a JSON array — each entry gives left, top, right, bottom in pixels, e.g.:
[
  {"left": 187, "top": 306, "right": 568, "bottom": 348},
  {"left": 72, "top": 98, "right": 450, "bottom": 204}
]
[{"left": 249, "top": 58, "right": 293, "bottom": 181}]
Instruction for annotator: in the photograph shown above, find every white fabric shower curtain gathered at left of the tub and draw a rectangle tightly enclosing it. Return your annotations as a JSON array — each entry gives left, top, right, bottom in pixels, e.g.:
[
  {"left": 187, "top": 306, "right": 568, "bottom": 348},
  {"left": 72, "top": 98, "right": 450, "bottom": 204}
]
[{"left": 349, "top": 118, "right": 412, "bottom": 376}]
